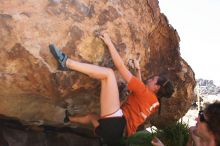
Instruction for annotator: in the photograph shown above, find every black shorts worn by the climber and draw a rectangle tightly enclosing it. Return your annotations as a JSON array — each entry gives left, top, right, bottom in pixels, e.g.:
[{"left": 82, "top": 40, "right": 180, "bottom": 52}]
[{"left": 95, "top": 116, "right": 126, "bottom": 146}]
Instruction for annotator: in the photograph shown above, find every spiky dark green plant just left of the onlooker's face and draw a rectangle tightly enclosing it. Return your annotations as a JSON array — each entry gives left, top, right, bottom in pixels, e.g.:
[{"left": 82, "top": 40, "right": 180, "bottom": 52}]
[{"left": 157, "top": 122, "right": 189, "bottom": 146}]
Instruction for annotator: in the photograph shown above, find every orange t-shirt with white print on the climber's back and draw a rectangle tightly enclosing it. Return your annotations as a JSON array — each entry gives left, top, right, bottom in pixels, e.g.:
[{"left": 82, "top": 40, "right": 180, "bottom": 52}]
[{"left": 121, "top": 76, "right": 159, "bottom": 136}]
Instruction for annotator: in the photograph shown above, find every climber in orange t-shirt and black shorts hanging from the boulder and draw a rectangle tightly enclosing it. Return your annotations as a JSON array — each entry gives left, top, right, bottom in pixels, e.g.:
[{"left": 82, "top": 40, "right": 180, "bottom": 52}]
[{"left": 49, "top": 32, "right": 174, "bottom": 145}]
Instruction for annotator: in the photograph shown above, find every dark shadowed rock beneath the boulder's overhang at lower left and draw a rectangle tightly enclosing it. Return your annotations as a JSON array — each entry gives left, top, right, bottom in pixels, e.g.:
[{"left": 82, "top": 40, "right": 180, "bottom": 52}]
[{"left": 0, "top": 115, "right": 102, "bottom": 146}]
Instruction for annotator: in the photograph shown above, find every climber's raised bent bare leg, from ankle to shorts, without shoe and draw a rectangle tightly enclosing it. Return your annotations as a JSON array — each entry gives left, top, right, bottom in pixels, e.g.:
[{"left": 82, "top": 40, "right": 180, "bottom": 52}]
[{"left": 66, "top": 59, "right": 120, "bottom": 117}]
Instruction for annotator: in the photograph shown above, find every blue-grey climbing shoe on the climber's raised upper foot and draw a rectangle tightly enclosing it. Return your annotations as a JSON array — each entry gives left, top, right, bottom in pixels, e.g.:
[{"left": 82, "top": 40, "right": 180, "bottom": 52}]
[{"left": 49, "top": 44, "right": 68, "bottom": 70}]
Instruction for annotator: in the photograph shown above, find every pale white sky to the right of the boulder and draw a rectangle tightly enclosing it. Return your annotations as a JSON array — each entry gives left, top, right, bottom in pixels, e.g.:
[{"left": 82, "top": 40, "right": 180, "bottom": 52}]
[{"left": 159, "top": 0, "right": 220, "bottom": 85}]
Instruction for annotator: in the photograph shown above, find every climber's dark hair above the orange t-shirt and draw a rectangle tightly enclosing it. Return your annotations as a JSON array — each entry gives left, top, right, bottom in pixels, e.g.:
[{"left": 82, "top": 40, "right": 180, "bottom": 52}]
[{"left": 156, "top": 75, "right": 174, "bottom": 98}]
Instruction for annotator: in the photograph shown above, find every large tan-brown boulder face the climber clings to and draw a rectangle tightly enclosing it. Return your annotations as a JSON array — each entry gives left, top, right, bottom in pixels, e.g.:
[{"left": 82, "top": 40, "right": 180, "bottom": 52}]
[{"left": 0, "top": 0, "right": 195, "bottom": 127}]
